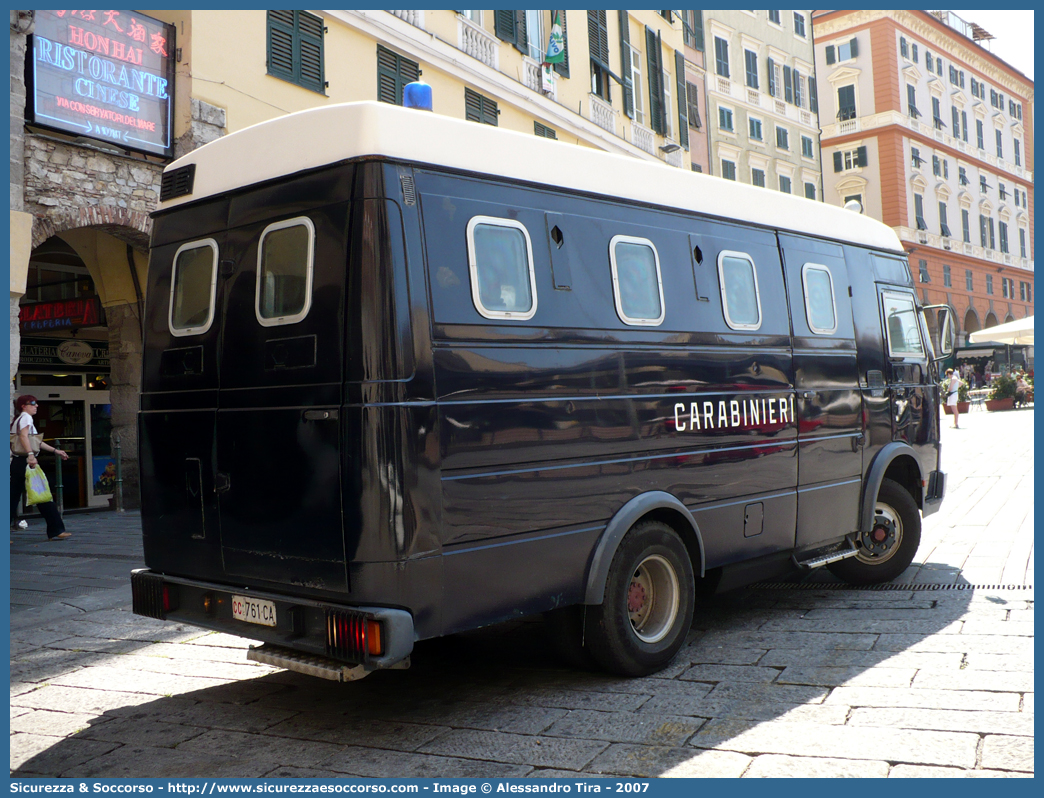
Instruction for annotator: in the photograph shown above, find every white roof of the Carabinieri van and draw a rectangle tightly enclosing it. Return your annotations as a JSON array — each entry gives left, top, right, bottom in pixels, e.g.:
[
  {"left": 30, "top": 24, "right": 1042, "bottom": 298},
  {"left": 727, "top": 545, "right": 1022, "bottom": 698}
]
[{"left": 159, "top": 102, "right": 903, "bottom": 253}]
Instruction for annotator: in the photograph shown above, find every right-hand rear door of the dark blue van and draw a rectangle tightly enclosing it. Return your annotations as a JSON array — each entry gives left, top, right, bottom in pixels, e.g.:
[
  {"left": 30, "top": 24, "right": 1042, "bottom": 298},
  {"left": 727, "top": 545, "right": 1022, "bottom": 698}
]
[{"left": 214, "top": 192, "right": 349, "bottom": 590}]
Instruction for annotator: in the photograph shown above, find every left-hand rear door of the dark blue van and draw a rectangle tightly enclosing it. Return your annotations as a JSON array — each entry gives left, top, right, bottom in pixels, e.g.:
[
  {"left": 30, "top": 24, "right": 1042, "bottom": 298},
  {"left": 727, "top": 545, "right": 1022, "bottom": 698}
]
[{"left": 138, "top": 200, "right": 228, "bottom": 579}]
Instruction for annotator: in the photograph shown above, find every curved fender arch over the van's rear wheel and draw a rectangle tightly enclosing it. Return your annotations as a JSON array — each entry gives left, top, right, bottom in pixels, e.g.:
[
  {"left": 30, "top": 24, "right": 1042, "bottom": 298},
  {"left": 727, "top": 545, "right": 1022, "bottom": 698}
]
[{"left": 584, "top": 491, "right": 706, "bottom": 605}]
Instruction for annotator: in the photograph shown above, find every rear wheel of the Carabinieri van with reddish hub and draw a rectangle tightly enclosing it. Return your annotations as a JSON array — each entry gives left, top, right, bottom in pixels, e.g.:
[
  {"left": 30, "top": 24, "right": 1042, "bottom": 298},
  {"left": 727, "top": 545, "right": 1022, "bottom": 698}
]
[{"left": 585, "top": 521, "right": 695, "bottom": 676}]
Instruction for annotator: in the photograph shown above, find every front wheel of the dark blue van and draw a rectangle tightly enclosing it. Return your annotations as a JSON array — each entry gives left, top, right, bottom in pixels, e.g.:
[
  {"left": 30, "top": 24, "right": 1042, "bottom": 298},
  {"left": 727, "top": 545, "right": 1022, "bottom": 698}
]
[{"left": 827, "top": 479, "right": 921, "bottom": 585}]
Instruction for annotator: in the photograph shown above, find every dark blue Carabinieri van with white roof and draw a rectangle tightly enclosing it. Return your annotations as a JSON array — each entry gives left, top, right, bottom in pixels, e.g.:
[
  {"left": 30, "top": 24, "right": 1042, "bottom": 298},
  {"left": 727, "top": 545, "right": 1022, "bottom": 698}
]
[{"left": 133, "top": 102, "right": 953, "bottom": 679}]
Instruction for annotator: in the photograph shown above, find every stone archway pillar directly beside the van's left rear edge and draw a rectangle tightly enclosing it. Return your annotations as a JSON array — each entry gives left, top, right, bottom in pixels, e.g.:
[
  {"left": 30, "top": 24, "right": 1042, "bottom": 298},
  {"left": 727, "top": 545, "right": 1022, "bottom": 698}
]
[{"left": 105, "top": 304, "right": 142, "bottom": 510}]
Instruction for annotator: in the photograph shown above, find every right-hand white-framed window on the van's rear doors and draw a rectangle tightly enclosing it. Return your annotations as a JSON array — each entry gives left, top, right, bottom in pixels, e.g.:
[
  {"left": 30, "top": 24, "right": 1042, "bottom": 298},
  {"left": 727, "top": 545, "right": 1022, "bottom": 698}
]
[{"left": 255, "top": 216, "right": 315, "bottom": 327}]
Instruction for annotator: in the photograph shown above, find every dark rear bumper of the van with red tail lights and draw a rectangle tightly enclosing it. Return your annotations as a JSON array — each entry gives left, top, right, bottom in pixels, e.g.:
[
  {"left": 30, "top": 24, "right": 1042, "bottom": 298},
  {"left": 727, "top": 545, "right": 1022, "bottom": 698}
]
[{"left": 131, "top": 568, "right": 414, "bottom": 671}]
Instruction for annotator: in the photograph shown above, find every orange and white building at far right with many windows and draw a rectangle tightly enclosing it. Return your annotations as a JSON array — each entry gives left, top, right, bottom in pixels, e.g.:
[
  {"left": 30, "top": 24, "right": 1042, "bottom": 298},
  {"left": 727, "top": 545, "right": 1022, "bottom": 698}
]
[{"left": 813, "top": 11, "right": 1034, "bottom": 343}]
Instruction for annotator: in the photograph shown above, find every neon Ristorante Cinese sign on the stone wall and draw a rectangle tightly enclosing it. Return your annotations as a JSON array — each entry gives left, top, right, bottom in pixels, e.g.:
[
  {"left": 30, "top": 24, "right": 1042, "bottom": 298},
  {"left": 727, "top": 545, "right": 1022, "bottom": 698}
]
[{"left": 28, "top": 10, "right": 174, "bottom": 157}]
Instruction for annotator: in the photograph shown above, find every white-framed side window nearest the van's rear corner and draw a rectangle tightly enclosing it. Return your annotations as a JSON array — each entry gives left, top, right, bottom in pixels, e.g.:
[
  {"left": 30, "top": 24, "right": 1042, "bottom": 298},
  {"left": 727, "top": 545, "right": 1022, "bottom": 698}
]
[{"left": 468, "top": 216, "right": 537, "bottom": 320}]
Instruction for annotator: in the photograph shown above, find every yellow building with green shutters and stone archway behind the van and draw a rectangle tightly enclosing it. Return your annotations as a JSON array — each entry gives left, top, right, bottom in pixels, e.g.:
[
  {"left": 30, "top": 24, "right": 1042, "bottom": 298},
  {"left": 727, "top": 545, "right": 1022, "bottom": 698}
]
[{"left": 9, "top": 10, "right": 707, "bottom": 508}]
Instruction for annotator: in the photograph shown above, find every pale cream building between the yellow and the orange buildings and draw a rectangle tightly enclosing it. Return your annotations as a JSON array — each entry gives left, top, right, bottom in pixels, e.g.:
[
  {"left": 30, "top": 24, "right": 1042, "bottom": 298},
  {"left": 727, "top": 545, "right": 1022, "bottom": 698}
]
[{"left": 703, "top": 10, "right": 823, "bottom": 200}]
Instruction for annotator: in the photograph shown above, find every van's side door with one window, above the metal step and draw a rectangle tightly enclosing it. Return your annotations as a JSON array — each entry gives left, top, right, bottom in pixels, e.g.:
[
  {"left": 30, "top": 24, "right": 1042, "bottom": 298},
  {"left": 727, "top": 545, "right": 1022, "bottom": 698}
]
[{"left": 780, "top": 235, "right": 863, "bottom": 548}]
